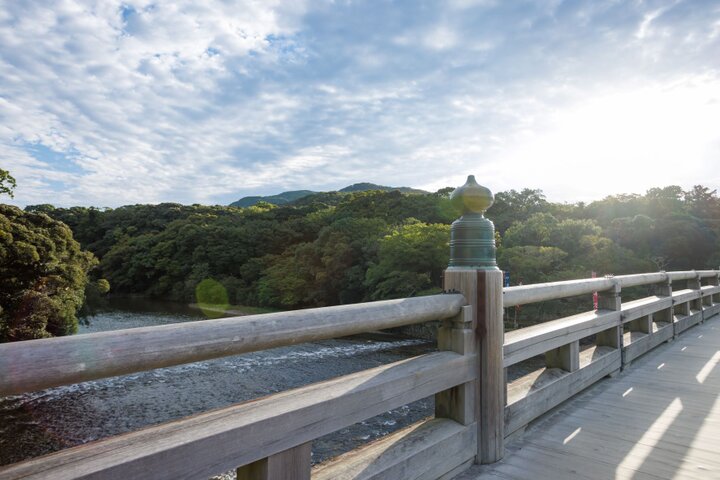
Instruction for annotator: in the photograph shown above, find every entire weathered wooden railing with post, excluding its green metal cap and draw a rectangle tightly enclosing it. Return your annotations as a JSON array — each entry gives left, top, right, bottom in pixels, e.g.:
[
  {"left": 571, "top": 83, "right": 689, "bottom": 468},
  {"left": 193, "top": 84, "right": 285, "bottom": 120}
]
[{"left": 0, "top": 268, "right": 720, "bottom": 480}]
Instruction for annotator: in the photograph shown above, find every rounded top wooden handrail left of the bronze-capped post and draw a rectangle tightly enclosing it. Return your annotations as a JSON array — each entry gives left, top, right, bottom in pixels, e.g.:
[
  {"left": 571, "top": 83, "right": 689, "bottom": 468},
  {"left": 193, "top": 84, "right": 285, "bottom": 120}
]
[{"left": 0, "top": 294, "right": 465, "bottom": 396}]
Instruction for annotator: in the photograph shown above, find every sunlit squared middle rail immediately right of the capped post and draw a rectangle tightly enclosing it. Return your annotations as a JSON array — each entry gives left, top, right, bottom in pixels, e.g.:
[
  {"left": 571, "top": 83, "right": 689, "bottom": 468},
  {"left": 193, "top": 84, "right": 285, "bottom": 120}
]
[{"left": 504, "top": 310, "right": 620, "bottom": 367}]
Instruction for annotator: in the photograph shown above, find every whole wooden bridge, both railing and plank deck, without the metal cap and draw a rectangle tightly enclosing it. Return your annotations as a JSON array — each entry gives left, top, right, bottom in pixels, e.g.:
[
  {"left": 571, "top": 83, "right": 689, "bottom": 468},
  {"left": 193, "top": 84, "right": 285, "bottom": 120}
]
[{"left": 0, "top": 177, "right": 720, "bottom": 480}]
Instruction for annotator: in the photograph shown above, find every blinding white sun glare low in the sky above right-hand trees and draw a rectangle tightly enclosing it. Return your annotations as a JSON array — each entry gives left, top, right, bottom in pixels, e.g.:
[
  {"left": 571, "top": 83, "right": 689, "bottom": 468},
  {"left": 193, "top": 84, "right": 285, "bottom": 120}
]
[{"left": 505, "top": 77, "right": 720, "bottom": 200}]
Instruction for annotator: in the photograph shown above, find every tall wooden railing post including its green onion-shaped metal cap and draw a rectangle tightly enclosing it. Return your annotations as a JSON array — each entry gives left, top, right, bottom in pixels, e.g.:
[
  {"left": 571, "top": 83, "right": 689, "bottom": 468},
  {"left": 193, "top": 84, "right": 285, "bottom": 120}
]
[{"left": 444, "top": 176, "right": 506, "bottom": 463}]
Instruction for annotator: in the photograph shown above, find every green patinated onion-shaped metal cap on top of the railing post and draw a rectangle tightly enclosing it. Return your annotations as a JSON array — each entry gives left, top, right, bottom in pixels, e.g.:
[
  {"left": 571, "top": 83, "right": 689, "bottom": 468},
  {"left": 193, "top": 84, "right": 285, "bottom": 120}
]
[{"left": 449, "top": 175, "right": 497, "bottom": 270}]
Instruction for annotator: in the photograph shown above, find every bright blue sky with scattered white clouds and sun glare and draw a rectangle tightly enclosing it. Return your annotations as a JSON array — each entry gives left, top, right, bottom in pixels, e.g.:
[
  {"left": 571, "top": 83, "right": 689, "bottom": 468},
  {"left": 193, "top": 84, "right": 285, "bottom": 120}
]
[{"left": 0, "top": 0, "right": 720, "bottom": 207}]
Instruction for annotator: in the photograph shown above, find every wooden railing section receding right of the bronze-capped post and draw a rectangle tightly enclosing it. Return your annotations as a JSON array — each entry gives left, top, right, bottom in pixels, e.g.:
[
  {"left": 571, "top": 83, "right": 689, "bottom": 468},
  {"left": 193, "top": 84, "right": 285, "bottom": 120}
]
[{"left": 503, "top": 270, "right": 720, "bottom": 436}]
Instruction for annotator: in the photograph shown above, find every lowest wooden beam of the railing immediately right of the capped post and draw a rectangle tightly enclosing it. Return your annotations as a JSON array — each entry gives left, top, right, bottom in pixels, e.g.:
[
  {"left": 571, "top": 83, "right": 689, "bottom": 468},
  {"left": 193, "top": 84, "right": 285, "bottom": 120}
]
[{"left": 505, "top": 347, "right": 621, "bottom": 435}]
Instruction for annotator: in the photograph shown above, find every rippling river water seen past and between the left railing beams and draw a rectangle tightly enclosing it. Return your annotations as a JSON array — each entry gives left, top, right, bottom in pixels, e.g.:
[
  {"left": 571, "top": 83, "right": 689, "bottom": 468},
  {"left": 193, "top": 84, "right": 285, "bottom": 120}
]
[{"left": 0, "top": 299, "right": 434, "bottom": 474}]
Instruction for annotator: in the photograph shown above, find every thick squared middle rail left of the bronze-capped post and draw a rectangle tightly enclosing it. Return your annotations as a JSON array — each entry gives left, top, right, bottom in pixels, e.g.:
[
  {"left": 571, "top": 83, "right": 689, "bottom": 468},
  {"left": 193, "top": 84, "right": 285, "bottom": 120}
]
[{"left": 0, "top": 352, "right": 477, "bottom": 480}]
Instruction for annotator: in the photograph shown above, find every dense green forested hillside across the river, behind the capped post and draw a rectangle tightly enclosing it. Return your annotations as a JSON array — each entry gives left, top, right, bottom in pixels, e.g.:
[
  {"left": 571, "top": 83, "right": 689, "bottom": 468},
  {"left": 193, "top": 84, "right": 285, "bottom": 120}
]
[{"left": 28, "top": 186, "right": 720, "bottom": 308}]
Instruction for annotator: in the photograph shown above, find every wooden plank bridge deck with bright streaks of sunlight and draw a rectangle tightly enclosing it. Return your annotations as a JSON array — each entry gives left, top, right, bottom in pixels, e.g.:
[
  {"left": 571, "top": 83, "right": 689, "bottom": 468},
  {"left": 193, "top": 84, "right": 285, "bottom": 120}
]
[{"left": 456, "top": 315, "right": 720, "bottom": 480}]
